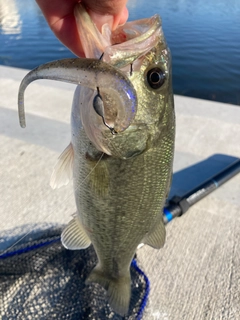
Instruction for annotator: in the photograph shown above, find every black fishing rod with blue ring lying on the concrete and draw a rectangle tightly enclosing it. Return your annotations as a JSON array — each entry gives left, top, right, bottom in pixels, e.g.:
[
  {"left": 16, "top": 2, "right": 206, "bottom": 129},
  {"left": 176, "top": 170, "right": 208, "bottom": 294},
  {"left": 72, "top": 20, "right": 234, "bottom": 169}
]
[{"left": 163, "top": 159, "right": 240, "bottom": 224}]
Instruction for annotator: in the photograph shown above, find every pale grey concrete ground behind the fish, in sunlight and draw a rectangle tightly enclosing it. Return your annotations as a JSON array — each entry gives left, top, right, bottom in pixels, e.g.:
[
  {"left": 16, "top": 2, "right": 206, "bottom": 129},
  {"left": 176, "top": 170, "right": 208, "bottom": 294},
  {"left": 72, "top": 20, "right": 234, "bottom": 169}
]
[{"left": 0, "top": 66, "right": 240, "bottom": 320}]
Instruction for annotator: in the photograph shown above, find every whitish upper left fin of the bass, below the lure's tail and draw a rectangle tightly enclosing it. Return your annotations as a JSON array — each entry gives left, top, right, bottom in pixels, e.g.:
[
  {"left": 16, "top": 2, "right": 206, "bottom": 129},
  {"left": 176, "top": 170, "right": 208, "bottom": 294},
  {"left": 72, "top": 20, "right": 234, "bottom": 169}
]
[{"left": 50, "top": 143, "right": 73, "bottom": 189}]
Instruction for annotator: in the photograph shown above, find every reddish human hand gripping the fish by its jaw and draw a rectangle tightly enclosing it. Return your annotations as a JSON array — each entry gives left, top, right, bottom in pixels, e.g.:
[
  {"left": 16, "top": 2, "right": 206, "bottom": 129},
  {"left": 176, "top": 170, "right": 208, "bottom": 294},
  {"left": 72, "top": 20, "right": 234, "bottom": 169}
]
[{"left": 36, "top": 0, "right": 128, "bottom": 57}]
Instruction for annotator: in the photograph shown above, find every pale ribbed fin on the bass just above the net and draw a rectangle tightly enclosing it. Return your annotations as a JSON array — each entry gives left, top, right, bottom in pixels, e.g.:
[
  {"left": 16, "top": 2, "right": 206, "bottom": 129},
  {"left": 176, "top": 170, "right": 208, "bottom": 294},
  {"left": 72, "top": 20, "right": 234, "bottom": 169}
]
[{"left": 61, "top": 216, "right": 91, "bottom": 250}]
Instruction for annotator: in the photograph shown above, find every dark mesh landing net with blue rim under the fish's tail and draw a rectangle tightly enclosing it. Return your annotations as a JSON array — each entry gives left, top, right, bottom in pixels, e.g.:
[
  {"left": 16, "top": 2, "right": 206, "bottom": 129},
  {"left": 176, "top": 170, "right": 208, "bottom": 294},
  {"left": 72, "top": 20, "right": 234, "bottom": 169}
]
[{"left": 0, "top": 228, "right": 149, "bottom": 320}]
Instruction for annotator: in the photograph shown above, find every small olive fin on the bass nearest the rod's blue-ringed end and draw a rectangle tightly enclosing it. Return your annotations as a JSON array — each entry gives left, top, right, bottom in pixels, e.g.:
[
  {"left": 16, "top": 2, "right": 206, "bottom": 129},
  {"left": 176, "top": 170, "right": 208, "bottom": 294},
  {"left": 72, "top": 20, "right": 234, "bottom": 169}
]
[{"left": 143, "top": 218, "right": 166, "bottom": 249}]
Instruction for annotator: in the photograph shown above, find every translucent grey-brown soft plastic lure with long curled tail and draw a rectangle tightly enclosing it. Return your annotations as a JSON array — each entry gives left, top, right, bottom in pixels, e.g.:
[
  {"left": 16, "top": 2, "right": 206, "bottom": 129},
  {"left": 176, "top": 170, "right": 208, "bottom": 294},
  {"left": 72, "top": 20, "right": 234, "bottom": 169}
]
[{"left": 18, "top": 58, "right": 137, "bottom": 145}]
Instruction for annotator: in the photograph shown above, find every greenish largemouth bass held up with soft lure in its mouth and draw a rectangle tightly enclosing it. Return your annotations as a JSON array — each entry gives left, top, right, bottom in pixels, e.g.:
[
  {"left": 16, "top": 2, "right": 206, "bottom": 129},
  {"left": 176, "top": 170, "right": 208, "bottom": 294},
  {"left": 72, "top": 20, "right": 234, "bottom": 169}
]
[{"left": 19, "top": 4, "right": 175, "bottom": 315}]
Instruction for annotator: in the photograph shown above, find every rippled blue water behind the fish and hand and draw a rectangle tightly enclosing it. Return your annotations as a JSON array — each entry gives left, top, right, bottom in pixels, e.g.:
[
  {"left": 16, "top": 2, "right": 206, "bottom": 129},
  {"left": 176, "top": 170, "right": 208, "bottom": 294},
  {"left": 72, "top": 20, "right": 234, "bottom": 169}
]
[{"left": 0, "top": 0, "right": 240, "bottom": 105}]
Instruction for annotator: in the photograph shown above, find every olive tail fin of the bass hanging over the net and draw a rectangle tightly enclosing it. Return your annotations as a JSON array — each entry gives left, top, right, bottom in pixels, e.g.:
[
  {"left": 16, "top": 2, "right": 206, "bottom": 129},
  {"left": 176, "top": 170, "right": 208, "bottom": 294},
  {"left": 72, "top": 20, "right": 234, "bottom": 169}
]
[{"left": 86, "top": 267, "right": 131, "bottom": 317}]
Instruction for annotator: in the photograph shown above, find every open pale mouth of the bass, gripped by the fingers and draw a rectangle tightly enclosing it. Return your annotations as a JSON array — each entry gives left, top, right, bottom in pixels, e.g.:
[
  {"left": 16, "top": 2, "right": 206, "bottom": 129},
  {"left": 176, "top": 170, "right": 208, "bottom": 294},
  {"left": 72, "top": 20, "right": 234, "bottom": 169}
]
[{"left": 74, "top": 3, "right": 163, "bottom": 70}]
